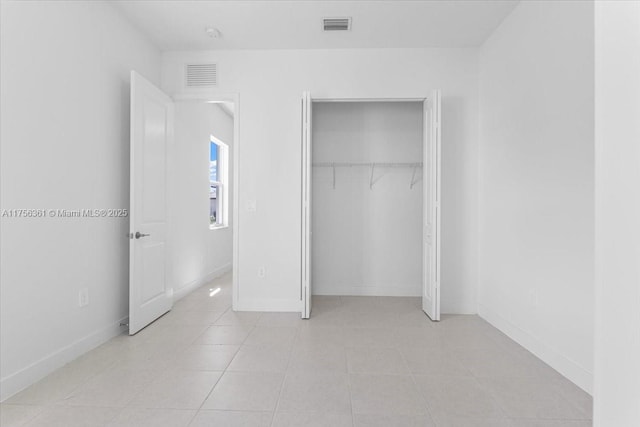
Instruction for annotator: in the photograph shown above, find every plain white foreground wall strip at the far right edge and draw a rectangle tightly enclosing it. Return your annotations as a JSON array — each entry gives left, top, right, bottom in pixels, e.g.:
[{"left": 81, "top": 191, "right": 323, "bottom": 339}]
[{"left": 594, "top": 2, "right": 640, "bottom": 427}]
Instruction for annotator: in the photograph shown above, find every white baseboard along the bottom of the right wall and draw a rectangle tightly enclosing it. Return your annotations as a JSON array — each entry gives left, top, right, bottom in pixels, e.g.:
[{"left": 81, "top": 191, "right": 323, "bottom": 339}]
[{"left": 478, "top": 304, "right": 593, "bottom": 394}]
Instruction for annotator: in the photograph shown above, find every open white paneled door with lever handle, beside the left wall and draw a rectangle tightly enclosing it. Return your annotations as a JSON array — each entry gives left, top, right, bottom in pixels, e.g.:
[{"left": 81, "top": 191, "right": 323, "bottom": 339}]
[{"left": 129, "top": 71, "right": 174, "bottom": 335}]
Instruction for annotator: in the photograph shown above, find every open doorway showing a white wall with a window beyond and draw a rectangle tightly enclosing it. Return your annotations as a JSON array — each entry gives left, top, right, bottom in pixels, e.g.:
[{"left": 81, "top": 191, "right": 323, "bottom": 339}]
[{"left": 169, "top": 100, "right": 235, "bottom": 308}]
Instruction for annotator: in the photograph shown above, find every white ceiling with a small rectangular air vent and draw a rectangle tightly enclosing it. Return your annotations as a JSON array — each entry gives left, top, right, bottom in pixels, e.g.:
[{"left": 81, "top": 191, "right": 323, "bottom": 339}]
[{"left": 111, "top": 0, "right": 518, "bottom": 51}]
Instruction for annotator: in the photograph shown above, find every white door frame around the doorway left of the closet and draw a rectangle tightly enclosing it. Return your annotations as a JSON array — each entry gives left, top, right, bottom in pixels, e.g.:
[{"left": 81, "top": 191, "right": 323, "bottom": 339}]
[{"left": 173, "top": 90, "right": 240, "bottom": 311}]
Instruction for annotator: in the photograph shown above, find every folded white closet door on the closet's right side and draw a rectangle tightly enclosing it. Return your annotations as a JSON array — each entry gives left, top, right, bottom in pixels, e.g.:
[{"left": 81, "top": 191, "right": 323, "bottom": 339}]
[{"left": 422, "top": 91, "right": 441, "bottom": 320}]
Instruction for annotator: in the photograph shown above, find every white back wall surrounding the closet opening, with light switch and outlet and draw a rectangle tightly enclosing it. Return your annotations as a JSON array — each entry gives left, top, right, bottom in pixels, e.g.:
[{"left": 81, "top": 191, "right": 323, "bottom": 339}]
[{"left": 163, "top": 49, "right": 478, "bottom": 313}]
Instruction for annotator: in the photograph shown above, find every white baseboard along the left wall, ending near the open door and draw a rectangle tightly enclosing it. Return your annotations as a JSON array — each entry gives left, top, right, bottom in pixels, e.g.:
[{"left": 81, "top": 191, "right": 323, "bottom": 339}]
[{"left": 0, "top": 317, "right": 128, "bottom": 402}]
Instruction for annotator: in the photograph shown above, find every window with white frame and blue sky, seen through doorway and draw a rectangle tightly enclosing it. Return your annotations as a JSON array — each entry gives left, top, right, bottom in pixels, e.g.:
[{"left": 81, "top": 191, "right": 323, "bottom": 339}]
[{"left": 209, "top": 135, "right": 229, "bottom": 228}]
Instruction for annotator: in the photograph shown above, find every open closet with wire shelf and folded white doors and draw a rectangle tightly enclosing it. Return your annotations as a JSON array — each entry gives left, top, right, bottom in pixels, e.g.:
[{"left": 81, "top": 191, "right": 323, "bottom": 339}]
[{"left": 301, "top": 92, "right": 440, "bottom": 320}]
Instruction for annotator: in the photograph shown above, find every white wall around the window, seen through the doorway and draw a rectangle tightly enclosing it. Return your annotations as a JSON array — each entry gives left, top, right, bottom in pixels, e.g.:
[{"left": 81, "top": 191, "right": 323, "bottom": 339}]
[{"left": 169, "top": 101, "right": 233, "bottom": 297}]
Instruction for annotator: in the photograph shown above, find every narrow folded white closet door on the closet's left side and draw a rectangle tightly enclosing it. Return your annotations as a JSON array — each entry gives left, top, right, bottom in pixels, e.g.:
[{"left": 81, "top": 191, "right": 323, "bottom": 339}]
[{"left": 300, "top": 92, "right": 312, "bottom": 319}]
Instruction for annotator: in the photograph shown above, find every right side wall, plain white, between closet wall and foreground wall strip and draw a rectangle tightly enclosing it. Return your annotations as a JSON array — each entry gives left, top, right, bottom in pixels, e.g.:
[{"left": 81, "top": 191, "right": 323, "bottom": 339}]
[{"left": 479, "top": 1, "right": 594, "bottom": 391}]
